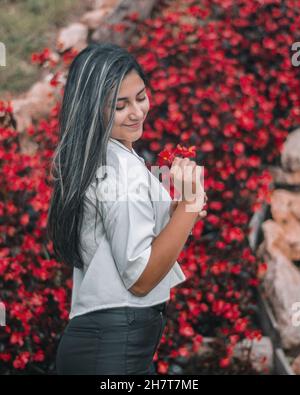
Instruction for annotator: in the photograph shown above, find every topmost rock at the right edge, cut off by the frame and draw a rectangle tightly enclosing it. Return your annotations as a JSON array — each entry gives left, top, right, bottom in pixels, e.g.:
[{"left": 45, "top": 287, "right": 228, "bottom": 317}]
[{"left": 281, "top": 128, "right": 300, "bottom": 171}]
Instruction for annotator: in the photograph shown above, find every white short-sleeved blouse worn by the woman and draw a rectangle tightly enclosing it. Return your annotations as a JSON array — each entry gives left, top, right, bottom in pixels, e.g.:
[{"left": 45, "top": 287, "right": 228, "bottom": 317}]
[{"left": 69, "top": 137, "right": 186, "bottom": 319}]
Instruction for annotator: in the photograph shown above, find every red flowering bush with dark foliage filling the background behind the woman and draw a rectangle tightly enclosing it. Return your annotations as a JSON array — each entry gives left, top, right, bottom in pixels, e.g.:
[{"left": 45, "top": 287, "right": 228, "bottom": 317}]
[{"left": 0, "top": 0, "right": 300, "bottom": 374}]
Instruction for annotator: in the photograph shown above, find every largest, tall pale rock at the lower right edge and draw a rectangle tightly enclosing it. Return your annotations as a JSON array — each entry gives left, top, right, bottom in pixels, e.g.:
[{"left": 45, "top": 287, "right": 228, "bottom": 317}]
[{"left": 260, "top": 229, "right": 300, "bottom": 349}]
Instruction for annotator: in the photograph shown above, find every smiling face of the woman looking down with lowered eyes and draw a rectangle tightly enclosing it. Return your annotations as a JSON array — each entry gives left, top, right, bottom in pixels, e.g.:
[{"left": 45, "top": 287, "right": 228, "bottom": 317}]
[{"left": 105, "top": 70, "right": 150, "bottom": 149}]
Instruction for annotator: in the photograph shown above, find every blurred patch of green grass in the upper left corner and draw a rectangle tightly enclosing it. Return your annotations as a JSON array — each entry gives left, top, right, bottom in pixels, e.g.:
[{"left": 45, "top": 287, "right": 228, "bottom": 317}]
[{"left": 0, "top": 0, "right": 85, "bottom": 100}]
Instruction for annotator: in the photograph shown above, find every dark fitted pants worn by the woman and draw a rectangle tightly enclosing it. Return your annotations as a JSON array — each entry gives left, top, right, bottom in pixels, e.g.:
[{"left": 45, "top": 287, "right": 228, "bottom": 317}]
[{"left": 56, "top": 302, "right": 168, "bottom": 375}]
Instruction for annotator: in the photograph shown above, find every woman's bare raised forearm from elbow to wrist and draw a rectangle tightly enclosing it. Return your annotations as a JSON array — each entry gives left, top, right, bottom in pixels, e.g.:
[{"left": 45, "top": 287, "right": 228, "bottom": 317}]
[{"left": 129, "top": 201, "right": 199, "bottom": 296}]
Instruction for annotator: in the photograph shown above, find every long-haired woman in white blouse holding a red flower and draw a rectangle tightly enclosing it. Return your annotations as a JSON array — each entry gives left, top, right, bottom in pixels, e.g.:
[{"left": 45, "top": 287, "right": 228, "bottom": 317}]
[{"left": 47, "top": 43, "right": 206, "bottom": 375}]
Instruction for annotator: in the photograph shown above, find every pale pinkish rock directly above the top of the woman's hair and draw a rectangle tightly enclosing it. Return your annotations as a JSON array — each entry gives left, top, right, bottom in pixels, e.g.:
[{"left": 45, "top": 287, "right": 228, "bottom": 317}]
[{"left": 56, "top": 23, "right": 88, "bottom": 52}]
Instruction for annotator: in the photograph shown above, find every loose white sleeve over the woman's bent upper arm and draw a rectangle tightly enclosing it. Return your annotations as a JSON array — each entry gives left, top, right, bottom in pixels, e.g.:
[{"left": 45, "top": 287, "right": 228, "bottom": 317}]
[{"left": 101, "top": 192, "right": 155, "bottom": 290}]
